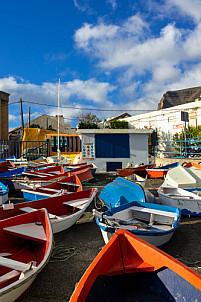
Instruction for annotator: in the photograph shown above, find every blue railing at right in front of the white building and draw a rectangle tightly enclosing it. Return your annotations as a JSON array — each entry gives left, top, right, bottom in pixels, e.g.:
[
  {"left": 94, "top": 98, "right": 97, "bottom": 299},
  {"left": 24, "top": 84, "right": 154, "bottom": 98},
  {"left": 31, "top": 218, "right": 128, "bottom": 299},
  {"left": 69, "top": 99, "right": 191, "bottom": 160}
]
[{"left": 149, "top": 137, "right": 201, "bottom": 158}]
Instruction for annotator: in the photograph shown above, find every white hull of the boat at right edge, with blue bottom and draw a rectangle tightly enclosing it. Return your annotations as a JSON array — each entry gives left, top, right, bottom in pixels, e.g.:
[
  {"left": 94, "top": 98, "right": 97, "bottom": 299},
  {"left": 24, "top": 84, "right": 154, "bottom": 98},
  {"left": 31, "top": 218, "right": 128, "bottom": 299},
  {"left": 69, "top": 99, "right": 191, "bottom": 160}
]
[{"left": 158, "top": 191, "right": 201, "bottom": 216}]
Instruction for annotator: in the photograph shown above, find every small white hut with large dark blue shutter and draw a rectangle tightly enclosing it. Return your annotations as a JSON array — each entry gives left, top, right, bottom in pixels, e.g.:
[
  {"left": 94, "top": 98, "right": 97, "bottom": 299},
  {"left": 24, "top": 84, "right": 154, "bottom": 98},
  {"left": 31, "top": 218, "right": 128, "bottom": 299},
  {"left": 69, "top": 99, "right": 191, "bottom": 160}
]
[{"left": 77, "top": 129, "right": 152, "bottom": 172}]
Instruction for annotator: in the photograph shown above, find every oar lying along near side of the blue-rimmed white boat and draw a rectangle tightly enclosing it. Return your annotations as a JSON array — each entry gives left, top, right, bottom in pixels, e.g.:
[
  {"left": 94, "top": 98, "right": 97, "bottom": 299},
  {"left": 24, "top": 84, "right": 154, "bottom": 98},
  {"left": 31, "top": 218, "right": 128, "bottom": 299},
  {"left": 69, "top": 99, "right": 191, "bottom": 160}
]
[{"left": 92, "top": 209, "right": 150, "bottom": 230}]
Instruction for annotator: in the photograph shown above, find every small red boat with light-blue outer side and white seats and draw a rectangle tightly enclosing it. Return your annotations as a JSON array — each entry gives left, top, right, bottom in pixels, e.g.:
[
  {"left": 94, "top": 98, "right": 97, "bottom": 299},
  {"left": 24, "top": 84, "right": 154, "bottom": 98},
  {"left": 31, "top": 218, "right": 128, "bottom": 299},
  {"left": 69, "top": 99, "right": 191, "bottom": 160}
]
[{"left": 21, "top": 175, "right": 82, "bottom": 201}]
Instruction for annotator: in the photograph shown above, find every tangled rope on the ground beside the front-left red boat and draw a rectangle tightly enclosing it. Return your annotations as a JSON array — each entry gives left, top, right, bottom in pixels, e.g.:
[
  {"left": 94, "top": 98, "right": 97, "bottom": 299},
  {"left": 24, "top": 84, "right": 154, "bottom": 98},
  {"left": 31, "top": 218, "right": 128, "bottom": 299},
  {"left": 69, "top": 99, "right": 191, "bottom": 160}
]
[{"left": 49, "top": 245, "right": 81, "bottom": 262}]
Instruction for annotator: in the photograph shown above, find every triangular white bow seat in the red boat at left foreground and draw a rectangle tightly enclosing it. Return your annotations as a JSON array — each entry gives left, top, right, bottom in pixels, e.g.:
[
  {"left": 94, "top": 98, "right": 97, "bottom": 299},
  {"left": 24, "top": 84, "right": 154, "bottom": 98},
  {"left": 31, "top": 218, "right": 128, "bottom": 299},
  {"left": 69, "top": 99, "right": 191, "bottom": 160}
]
[{"left": 3, "top": 222, "right": 47, "bottom": 242}]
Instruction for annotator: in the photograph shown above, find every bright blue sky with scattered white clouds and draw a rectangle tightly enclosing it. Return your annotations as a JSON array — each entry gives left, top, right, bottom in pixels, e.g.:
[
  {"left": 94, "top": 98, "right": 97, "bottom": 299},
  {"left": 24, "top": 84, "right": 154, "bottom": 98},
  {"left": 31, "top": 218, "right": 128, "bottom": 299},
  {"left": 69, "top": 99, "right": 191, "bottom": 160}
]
[{"left": 0, "top": 0, "right": 201, "bottom": 129}]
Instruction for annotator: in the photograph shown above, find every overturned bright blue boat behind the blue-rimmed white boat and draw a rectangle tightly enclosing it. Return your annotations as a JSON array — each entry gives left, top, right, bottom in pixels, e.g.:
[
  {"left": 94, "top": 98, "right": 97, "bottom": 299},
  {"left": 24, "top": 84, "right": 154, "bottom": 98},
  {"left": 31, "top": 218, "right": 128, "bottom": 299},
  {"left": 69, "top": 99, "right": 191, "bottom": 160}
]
[{"left": 99, "top": 177, "right": 157, "bottom": 208}]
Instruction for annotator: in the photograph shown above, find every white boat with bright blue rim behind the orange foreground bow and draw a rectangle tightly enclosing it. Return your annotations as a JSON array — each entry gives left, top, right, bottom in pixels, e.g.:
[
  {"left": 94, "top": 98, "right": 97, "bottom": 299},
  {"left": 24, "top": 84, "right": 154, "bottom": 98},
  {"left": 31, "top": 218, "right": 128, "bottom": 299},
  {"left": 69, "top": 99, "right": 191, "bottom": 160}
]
[{"left": 93, "top": 201, "right": 181, "bottom": 247}]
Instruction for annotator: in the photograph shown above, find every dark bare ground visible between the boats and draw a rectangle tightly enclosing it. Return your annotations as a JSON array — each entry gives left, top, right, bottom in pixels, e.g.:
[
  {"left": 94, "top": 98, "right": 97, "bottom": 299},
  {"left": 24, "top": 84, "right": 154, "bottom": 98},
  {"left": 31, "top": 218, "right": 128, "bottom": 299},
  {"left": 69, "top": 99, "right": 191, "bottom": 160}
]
[{"left": 20, "top": 173, "right": 201, "bottom": 302}]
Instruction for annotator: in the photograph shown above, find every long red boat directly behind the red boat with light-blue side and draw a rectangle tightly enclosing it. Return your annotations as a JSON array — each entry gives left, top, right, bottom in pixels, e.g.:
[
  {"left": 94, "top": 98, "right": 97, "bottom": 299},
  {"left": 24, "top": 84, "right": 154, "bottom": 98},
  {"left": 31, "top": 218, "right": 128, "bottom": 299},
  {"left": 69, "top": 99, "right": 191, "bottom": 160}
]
[{"left": 12, "top": 167, "right": 93, "bottom": 191}]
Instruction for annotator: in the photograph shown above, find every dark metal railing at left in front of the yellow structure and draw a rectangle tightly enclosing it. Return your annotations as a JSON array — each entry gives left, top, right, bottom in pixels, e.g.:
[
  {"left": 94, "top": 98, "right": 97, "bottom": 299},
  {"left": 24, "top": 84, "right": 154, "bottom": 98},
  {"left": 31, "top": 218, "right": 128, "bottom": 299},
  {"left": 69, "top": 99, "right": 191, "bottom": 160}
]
[{"left": 0, "top": 140, "right": 49, "bottom": 160}]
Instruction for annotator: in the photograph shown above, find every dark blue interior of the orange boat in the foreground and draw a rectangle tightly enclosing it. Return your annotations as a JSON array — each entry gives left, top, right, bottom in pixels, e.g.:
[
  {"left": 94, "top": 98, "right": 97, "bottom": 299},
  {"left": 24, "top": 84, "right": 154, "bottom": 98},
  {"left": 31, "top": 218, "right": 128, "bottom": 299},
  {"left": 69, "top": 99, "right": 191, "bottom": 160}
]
[{"left": 85, "top": 267, "right": 201, "bottom": 302}]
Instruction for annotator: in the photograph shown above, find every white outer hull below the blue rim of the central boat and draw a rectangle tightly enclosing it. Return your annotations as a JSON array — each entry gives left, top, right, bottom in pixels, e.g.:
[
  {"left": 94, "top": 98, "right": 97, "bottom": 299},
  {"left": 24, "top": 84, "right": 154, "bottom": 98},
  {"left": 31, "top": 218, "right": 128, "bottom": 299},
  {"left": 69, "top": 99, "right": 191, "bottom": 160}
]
[{"left": 101, "top": 226, "right": 173, "bottom": 247}]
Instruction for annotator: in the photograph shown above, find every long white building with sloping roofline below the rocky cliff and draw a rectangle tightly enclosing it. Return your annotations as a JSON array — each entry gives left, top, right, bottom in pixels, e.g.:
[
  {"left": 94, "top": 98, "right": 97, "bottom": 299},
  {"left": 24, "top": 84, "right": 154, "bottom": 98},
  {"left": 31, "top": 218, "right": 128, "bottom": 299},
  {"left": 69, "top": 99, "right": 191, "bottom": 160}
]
[{"left": 122, "top": 98, "right": 201, "bottom": 140}]
